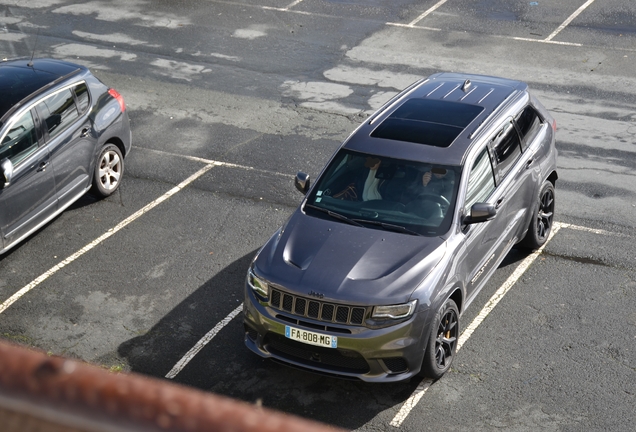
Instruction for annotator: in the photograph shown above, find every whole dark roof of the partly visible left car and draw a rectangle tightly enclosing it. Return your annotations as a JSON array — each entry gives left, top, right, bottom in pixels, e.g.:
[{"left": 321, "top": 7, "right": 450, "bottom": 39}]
[{"left": 0, "top": 59, "right": 86, "bottom": 119}]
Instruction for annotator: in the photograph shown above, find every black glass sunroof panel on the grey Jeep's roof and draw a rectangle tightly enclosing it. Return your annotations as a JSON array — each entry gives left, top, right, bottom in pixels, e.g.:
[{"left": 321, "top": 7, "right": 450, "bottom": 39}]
[{"left": 371, "top": 99, "right": 483, "bottom": 147}]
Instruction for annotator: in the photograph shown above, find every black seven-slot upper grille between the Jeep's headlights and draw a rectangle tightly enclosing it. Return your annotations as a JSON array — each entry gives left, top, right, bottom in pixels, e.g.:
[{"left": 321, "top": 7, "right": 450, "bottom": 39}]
[{"left": 270, "top": 289, "right": 367, "bottom": 325}]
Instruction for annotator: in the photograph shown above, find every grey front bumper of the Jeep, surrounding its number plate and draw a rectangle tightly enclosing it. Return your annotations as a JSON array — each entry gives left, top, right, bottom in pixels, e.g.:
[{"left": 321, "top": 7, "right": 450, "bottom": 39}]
[{"left": 243, "top": 287, "right": 428, "bottom": 382}]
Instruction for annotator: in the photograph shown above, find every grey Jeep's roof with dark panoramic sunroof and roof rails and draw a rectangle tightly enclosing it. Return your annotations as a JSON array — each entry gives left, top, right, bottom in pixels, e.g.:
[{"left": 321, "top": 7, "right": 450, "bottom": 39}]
[{"left": 345, "top": 73, "right": 528, "bottom": 165}]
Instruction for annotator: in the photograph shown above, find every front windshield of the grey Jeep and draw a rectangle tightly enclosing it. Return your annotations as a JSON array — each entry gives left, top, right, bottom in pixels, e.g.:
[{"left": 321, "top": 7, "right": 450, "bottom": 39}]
[{"left": 304, "top": 150, "right": 460, "bottom": 236}]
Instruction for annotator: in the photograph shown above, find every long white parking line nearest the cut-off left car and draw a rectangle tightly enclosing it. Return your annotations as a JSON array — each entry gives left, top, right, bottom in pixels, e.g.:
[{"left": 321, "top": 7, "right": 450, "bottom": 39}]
[{"left": 0, "top": 162, "right": 220, "bottom": 314}]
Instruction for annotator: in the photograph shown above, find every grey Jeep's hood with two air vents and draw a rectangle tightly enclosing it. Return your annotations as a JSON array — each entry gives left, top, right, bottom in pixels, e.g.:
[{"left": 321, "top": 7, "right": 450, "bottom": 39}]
[{"left": 254, "top": 210, "right": 446, "bottom": 304}]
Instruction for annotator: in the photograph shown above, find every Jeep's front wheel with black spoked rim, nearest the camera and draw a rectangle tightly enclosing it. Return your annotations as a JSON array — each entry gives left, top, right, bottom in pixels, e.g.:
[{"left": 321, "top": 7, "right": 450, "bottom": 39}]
[{"left": 420, "top": 299, "right": 459, "bottom": 379}]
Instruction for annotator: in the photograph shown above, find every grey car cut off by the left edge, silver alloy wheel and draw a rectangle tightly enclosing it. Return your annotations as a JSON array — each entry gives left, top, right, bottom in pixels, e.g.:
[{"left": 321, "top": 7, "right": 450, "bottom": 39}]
[{"left": 0, "top": 59, "right": 131, "bottom": 253}]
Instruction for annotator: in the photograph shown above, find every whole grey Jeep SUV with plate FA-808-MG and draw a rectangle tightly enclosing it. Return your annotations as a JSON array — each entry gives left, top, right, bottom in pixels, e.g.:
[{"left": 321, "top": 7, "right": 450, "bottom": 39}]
[{"left": 244, "top": 73, "right": 557, "bottom": 381}]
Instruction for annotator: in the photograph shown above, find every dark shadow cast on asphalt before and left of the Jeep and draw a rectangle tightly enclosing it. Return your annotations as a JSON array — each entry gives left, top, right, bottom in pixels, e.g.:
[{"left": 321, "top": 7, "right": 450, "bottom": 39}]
[{"left": 118, "top": 251, "right": 420, "bottom": 429}]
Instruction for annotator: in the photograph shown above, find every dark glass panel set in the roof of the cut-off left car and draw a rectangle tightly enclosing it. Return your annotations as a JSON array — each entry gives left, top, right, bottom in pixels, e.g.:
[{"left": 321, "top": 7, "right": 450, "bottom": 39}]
[{"left": 0, "top": 65, "right": 59, "bottom": 118}]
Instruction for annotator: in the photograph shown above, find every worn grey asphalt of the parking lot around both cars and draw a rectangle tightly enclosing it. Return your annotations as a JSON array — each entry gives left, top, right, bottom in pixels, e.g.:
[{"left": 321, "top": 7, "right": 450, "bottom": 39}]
[{"left": 0, "top": 0, "right": 636, "bottom": 431}]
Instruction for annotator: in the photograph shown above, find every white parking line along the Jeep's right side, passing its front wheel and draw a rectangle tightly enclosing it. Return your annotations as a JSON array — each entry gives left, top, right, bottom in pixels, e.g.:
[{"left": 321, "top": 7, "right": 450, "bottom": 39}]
[{"left": 389, "top": 222, "right": 571, "bottom": 427}]
